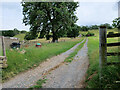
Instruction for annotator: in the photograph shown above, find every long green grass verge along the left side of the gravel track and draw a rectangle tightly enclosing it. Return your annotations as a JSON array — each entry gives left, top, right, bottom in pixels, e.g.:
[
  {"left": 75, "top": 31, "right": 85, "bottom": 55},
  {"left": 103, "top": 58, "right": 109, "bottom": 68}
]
[{"left": 2, "top": 38, "right": 83, "bottom": 81}]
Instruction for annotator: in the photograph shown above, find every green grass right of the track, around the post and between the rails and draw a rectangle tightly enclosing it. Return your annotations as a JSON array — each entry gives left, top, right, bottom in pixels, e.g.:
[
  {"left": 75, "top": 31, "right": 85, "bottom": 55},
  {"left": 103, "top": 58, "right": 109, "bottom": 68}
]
[{"left": 86, "top": 30, "right": 120, "bottom": 88}]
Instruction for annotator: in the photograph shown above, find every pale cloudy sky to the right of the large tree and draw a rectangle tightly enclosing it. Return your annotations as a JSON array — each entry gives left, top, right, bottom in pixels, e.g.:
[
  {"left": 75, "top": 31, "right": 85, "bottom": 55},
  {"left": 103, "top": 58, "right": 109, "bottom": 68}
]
[{"left": 77, "top": 3, "right": 118, "bottom": 25}]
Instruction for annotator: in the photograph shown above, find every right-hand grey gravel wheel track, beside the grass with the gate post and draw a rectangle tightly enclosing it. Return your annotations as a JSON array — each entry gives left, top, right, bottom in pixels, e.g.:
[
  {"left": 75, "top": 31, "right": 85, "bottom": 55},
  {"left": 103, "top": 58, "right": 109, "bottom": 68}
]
[{"left": 42, "top": 39, "right": 89, "bottom": 88}]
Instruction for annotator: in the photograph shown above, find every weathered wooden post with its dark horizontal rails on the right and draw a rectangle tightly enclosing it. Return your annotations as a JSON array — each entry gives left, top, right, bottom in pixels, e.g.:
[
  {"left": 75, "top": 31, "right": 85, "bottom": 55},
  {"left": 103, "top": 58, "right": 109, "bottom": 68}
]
[{"left": 99, "top": 26, "right": 120, "bottom": 68}]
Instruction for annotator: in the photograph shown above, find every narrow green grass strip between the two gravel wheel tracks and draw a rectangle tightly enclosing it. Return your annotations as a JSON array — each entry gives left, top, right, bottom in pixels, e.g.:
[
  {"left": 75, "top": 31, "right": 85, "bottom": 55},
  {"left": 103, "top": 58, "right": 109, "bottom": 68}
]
[{"left": 65, "top": 40, "right": 86, "bottom": 62}]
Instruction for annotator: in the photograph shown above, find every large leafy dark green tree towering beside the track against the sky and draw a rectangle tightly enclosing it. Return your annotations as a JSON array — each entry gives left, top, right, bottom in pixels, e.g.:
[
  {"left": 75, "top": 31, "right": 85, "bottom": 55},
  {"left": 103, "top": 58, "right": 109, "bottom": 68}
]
[{"left": 22, "top": 2, "right": 78, "bottom": 42}]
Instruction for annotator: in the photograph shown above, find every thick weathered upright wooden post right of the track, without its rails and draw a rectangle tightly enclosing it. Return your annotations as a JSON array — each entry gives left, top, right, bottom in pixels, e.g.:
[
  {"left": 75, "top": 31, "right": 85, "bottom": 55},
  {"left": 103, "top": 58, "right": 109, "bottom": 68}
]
[{"left": 99, "top": 26, "right": 107, "bottom": 87}]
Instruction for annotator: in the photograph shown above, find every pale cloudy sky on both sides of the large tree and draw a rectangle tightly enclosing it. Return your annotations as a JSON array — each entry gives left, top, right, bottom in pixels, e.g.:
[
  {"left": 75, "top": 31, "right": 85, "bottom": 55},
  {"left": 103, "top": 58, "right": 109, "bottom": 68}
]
[{"left": 0, "top": 1, "right": 118, "bottom": 31}]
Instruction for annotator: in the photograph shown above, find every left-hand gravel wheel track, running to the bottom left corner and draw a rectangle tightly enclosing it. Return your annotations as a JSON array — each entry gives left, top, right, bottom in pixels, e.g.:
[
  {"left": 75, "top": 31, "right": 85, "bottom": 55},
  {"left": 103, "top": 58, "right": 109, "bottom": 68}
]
[{"left": 2, "top": 39, "right": 87, "bottom": 88}]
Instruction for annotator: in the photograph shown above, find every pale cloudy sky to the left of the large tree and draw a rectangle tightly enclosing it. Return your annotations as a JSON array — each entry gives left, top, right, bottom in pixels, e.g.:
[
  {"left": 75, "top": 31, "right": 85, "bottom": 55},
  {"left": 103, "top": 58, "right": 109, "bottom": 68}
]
[{"left": 0, "top": 2, "right": 29, "bottom": 30}]
